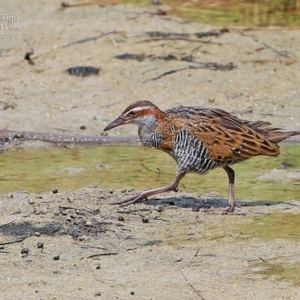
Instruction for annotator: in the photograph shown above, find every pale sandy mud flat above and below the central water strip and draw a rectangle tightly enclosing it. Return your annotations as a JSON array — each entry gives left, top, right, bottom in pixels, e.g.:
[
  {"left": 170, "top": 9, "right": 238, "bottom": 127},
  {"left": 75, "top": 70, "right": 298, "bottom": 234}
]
[{"left": 0, "top": 1, "right": 300, "bottom": 300}]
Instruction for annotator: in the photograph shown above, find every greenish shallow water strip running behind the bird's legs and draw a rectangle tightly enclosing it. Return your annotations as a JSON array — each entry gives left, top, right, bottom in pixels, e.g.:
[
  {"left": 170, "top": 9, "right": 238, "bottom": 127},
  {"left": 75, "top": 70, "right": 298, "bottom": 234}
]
[{"left": 0, "top": 145, "right": 300, "bottom": 201}]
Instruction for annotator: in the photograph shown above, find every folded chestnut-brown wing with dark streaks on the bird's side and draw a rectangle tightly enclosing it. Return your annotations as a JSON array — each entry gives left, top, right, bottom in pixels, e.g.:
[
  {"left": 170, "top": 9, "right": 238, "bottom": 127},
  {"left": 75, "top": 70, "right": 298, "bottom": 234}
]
[{"left": 187, "top": 108, "right": 279, "bottom": 161}]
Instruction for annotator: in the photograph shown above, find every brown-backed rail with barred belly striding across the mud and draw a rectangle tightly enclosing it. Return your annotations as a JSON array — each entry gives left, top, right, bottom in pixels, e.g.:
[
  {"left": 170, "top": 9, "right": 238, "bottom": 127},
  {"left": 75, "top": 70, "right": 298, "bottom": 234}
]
[{"left": 104, "top": 100, "right": 300, "bottom": 213}]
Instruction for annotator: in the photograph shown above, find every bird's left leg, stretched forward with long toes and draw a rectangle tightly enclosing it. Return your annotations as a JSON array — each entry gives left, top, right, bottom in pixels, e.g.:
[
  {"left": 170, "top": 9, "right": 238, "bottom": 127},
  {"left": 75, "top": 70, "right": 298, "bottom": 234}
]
[{"left": 112, "top": 173, "right": 185, "bottom": 206}]
